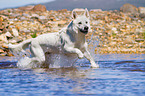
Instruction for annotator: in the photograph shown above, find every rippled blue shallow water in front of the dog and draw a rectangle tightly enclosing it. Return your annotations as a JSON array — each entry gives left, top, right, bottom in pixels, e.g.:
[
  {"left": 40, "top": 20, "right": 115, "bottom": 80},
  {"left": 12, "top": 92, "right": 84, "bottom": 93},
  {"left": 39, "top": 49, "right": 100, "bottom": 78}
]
[{"left": 0, "top": 54, "right": 145, "bottom": 96}]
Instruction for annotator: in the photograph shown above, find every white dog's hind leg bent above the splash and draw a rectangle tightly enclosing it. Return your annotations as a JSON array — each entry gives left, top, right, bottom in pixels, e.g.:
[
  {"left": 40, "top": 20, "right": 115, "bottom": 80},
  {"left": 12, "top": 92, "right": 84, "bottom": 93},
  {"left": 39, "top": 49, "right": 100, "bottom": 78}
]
[{"left": 30, "top": 43, "right": 45, "bottom": 64}]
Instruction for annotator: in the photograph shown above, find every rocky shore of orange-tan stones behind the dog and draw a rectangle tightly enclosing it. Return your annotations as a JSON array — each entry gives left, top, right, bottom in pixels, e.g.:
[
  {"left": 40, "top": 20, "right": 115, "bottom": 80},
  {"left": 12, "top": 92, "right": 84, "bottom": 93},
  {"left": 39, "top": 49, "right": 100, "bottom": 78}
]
[{"left": 0, "top": 5, "right": 145, "bottom": 56}]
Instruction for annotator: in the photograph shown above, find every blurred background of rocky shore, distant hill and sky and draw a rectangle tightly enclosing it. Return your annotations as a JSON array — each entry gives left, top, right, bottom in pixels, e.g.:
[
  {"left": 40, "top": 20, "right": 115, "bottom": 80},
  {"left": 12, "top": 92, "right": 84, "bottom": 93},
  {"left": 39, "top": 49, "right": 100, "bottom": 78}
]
[{"left": 0, "top": 0, "right": 145, "bottom": 56}]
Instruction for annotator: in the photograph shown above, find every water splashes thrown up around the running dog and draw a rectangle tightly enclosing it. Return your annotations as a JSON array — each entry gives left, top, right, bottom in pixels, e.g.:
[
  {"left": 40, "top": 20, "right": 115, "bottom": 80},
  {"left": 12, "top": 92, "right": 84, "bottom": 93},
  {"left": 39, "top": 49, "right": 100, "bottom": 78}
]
[{"left": 10, "top": 30, "right": 99, "bottom": 68}]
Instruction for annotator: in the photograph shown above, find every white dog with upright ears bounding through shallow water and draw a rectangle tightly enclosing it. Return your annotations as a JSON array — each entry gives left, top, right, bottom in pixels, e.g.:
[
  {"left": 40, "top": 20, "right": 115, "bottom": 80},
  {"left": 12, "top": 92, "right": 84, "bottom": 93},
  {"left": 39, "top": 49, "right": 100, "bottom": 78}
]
[{"left": 9, "top": 9, "right": 99, "bottom": 68}]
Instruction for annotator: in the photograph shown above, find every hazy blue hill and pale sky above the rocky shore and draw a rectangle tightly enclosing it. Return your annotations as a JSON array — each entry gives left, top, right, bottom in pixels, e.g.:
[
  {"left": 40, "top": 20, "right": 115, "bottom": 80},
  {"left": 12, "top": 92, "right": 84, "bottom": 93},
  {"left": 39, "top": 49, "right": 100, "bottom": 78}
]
[{"left": 0, "top": 0, "right": 145, "bottom": 10}]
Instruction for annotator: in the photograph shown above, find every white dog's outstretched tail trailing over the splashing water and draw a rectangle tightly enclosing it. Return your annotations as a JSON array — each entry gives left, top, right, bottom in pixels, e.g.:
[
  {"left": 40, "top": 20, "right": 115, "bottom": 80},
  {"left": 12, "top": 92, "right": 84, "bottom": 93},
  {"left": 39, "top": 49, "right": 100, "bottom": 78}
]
[{"left": 8, "top": 39, "right": 32, "bottom": 54}]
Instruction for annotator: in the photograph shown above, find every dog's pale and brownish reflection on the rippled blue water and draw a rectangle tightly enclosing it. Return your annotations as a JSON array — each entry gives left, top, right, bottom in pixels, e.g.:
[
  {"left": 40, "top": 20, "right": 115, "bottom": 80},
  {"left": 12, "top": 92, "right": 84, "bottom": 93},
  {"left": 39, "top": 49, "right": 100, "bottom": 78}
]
[{"left": 34, "top": 67, "right": 92, "bottom": 93}]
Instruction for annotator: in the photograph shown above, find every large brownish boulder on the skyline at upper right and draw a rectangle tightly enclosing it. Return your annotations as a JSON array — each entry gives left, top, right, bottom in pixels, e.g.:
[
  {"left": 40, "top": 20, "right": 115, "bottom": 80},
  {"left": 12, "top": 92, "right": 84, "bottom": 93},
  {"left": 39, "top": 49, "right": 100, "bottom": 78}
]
[{"left": 120, "top": 3, "right": 138, "bottom": 14}]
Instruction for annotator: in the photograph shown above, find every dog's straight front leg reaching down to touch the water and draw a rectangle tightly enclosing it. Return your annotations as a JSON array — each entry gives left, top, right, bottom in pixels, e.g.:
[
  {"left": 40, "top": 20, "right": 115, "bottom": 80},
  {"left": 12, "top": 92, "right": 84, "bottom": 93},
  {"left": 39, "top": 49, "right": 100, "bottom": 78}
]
[{"left": 83, "top": 44, "right": 99, "bottom": 68}]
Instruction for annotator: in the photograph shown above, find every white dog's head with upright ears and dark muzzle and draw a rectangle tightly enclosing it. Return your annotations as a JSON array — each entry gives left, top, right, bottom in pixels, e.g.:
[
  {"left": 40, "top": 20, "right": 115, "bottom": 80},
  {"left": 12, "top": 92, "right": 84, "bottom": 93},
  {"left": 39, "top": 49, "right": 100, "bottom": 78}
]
[{"left": 72, "top": 9, "right": 90, "bottom": 34}]
